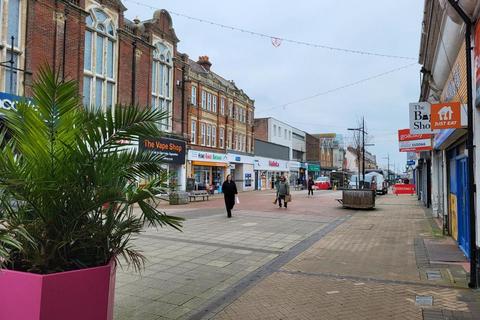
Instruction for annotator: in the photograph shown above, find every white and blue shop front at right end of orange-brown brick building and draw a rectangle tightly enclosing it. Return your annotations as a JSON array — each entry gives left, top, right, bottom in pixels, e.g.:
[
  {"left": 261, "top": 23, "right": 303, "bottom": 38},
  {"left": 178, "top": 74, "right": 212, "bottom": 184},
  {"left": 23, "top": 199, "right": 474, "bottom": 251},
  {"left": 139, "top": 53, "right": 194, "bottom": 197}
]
[{"left": 227, "top": 153, "right": 255, "bottom": 191}]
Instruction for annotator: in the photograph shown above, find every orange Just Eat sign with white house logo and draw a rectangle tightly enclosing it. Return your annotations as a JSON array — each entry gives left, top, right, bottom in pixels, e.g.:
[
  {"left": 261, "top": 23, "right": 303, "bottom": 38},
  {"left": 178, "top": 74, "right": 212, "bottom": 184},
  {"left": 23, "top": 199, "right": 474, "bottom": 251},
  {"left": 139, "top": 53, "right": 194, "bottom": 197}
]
[{"left": 431, "top": 102, "right": 462, "bottom": 130}]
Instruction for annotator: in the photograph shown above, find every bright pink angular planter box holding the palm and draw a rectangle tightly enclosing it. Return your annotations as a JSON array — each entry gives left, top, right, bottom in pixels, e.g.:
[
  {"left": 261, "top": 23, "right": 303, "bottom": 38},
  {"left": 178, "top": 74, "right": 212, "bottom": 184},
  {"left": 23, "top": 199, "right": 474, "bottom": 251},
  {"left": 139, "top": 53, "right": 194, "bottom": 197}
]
[{"left": 0, "top": 262, "right": 116, "bottom": 320}]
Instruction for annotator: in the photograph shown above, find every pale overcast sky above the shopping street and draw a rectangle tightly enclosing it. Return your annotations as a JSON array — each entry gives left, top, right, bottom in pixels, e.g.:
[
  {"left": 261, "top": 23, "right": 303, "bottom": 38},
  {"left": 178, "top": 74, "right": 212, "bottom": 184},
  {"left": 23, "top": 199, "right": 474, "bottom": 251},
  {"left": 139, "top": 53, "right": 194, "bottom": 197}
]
[{"left": 123, "top": 0, "right": 423, "bottom": 169}]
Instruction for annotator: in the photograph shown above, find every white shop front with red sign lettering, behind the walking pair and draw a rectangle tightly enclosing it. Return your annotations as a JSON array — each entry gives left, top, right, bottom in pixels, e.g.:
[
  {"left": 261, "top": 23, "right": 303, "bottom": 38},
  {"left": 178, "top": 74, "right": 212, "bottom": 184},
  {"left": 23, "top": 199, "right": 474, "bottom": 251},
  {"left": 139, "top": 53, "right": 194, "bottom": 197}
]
[{"left": 253, "top": 157, "right": 290, "bottom": 190}]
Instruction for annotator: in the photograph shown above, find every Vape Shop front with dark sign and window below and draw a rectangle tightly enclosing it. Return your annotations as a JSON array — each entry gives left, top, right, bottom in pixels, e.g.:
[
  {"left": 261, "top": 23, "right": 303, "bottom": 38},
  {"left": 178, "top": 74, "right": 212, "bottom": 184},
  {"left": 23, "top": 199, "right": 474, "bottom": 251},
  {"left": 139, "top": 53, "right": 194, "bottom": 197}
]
[{"left": 139, "top": 137, "right": 186, "bottom": 191}]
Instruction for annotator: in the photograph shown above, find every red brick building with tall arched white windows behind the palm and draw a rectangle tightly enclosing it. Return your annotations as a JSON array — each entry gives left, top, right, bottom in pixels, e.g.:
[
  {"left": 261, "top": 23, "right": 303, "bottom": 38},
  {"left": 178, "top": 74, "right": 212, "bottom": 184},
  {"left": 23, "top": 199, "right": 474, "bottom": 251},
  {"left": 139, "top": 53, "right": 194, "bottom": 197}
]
[{"left": 0, "top": 0, "right": 197, "bottom": 189}]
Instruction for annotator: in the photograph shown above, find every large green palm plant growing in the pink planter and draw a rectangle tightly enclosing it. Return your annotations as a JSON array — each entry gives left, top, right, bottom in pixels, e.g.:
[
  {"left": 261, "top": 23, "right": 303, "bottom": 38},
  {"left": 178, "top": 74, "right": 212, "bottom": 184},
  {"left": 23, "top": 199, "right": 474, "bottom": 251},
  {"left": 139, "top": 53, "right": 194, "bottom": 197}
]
[{"left": 0, "top": 68, "right": 182, "bottom": 274}]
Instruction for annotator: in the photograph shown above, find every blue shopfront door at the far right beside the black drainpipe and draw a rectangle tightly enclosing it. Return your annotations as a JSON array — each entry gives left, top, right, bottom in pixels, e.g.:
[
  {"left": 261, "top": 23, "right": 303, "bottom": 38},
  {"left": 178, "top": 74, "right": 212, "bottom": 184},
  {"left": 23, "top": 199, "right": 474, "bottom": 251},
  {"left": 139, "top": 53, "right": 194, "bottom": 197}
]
[{"left": 457, "top": 157, "right": 470, "bottom": 258}]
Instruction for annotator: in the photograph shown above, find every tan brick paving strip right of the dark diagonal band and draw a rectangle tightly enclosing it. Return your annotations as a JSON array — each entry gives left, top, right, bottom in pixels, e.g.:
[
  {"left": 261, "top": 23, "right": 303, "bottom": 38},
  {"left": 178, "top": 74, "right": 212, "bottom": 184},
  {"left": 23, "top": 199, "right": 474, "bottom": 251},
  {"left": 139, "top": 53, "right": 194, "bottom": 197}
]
[{"left": 213, "top": 196, "right": 480, "bottom": 320}]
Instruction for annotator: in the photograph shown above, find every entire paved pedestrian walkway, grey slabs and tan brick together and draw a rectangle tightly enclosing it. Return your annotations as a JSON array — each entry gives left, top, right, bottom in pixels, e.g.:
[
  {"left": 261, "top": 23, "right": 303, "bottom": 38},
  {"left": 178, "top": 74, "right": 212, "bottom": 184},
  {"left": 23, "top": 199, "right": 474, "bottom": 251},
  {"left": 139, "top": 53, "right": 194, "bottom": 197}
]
[{"left": 115, "top": 191, "right": 480, "bottom": 320}]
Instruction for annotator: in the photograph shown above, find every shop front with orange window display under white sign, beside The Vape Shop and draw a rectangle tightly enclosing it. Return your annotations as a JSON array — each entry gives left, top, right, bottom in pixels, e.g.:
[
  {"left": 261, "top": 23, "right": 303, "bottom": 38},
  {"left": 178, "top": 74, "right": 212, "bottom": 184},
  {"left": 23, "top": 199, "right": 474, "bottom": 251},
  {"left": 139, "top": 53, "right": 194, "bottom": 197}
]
[{"left": 187, "top": 150, "right": 228, "bottom": 193}]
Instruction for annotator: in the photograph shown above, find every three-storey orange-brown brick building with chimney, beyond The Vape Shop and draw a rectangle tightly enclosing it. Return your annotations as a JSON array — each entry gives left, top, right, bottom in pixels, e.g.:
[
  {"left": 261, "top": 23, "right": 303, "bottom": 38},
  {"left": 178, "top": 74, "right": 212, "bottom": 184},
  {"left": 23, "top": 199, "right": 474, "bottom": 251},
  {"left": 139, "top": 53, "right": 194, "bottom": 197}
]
[{"left": 183, "top": 56, "right": 254, "bottom": 190}]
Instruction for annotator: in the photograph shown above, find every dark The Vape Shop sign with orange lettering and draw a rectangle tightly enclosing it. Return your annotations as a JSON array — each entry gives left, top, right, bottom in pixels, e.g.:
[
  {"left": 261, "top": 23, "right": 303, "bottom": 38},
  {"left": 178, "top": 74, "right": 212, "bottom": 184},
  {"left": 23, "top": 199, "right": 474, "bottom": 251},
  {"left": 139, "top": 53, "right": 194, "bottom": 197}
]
[{"left": 139, "top": 137, "right": 186, "bottom": 164}]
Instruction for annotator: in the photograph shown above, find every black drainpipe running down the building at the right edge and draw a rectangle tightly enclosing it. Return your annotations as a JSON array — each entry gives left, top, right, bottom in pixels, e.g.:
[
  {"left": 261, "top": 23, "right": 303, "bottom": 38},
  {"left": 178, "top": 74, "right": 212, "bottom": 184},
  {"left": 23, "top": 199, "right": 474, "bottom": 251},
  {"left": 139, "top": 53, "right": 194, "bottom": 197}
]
[{"left": 448, "top": 0, "right": 479, "bottom": 289}]
